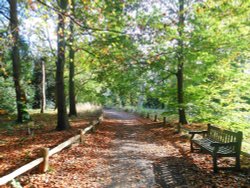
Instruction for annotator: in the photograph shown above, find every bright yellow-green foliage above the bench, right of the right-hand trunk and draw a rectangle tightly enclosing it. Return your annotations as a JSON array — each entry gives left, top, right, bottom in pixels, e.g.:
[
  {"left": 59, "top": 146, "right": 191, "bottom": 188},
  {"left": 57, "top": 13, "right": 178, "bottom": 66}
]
[{"left": 182, "top": 1, "right": 250, "bottom": 137}]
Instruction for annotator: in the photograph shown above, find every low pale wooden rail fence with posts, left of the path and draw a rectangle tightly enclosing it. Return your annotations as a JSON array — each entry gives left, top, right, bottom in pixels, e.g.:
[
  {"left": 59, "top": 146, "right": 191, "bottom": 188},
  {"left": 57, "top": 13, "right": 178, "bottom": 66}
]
[{"left": 0, "top": 116, "right": 103, "bottom": 186}]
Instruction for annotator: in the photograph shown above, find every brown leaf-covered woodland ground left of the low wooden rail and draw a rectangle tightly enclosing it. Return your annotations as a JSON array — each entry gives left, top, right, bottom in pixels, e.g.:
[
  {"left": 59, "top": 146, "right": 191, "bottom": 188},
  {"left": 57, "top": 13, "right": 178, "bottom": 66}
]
[{"left": 0, "top": 113, "right": 98, "bottom": 176}]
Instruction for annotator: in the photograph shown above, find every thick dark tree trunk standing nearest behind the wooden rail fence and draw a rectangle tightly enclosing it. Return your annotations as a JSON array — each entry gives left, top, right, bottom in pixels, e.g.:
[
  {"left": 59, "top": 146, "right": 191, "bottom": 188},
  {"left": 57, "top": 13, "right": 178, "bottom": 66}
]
[{"left": 56, "top": 0, "right": 70, "bottom": 130}]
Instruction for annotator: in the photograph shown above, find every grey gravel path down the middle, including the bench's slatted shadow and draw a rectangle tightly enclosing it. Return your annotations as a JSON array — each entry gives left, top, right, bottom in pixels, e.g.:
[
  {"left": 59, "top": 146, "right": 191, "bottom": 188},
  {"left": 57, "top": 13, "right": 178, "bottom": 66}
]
[{"left": 94, "top": 110, "right": 185, "bottom": 188}]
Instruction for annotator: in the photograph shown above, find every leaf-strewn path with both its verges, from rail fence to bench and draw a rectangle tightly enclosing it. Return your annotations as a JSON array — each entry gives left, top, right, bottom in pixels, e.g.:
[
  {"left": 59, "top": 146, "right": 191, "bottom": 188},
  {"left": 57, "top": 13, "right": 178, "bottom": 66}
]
[{"left": 1, "top": 110, "right": 250, "bottom": 188}]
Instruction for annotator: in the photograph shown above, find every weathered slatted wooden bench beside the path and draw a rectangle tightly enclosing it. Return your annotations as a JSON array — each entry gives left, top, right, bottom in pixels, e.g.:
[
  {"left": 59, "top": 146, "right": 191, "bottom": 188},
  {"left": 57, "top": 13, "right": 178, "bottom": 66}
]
[{"left": 189, "top": 124, "right": 243, "bottom": 173}]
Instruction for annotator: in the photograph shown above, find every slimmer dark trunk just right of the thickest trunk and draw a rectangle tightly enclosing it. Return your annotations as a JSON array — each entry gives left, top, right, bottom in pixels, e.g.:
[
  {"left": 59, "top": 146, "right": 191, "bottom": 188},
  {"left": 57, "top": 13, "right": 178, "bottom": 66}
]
[{"left": 69, "top": 0, "right": 77, "bottom": 116}]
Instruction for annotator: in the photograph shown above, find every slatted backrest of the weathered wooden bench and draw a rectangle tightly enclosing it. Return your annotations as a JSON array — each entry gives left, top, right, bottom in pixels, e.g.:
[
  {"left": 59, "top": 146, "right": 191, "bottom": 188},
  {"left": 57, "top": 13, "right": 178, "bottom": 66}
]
[{"left": 208, "top": 124, "right": 243, "bottom": 151}]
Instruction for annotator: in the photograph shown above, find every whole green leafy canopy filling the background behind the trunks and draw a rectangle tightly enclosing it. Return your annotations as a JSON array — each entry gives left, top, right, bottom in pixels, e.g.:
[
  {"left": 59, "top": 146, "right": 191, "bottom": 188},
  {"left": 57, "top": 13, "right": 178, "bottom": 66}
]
[{"left": 0, "top": 0, "right": 250, "bottom": 142}]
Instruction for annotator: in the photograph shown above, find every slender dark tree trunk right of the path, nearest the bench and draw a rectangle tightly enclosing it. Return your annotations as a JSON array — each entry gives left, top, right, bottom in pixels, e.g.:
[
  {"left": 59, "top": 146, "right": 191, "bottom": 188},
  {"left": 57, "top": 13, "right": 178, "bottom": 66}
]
[{"left": 176, "top": 0, "right": 188, "bottom": 124}]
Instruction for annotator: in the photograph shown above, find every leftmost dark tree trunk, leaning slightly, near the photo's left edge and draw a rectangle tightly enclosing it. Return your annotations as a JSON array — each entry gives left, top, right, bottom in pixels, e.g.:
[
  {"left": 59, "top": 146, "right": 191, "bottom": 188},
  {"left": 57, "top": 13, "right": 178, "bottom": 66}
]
[{"left": 9, "top": 0, "right": 29, "bottom": 123}]
